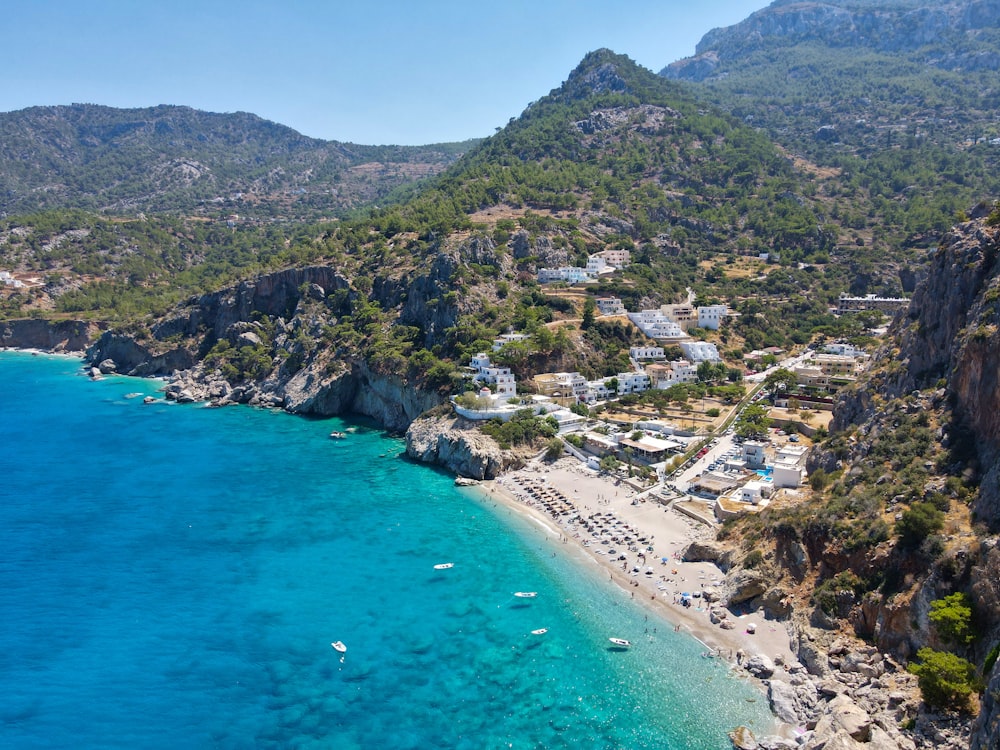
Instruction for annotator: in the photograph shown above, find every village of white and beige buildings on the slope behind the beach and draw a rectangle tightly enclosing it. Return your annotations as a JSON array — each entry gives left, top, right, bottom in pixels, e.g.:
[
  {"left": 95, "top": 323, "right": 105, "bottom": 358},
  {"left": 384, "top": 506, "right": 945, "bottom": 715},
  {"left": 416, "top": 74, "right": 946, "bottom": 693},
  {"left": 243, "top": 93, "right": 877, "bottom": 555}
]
[{"left": 452, "top": 268, "right": 872, "bottom": 523}]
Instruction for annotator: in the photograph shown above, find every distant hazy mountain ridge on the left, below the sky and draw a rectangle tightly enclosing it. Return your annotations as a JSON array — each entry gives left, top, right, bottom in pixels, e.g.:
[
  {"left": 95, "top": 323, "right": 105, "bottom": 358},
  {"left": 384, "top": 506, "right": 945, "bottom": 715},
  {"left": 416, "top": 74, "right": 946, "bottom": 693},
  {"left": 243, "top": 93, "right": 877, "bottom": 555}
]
[{"left": 0, "top": 104, "right": 474, "bottom": 218}]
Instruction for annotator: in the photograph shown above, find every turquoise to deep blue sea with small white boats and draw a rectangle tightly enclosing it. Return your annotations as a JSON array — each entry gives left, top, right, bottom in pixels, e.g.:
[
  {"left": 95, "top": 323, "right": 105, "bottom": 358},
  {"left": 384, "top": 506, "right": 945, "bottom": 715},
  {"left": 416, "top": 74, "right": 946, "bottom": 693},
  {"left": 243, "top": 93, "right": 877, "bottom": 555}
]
[{"left": 0, "top": 352, "right": 772, "bottom": 750}]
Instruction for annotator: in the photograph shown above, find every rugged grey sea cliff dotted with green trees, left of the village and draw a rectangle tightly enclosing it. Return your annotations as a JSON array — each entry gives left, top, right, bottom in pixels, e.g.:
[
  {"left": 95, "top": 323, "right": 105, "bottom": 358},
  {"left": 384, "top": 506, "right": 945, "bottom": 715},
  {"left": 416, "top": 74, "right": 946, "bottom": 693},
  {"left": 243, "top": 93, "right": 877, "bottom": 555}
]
[{"left": 87, "top": 266, "right": 442, "bottom": 430}]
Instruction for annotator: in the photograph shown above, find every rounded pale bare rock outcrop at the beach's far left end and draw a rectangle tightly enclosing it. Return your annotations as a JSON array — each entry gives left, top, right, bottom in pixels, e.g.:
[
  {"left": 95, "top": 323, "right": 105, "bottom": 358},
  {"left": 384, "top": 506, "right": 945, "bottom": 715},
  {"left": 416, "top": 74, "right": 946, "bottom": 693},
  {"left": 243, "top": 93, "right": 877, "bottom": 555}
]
[{"left": 406, "top": 416, "right": 524, "bottom": 479}]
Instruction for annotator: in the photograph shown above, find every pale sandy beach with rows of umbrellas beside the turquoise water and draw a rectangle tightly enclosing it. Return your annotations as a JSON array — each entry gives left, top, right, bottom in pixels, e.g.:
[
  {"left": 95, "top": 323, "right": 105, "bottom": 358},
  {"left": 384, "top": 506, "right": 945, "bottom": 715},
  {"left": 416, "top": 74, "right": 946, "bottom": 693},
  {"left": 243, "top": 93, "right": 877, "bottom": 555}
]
[{"left": 479, "top": 458, "right": 798, "bottom": 728}]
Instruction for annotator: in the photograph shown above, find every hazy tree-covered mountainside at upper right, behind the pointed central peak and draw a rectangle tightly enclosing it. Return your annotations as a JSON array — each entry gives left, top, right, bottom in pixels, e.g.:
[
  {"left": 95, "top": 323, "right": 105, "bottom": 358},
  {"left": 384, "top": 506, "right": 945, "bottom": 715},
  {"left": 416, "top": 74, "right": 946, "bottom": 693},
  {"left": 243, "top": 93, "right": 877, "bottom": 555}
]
[{"left": 662, "top": 0, "right": 1000, "bottom": 258}]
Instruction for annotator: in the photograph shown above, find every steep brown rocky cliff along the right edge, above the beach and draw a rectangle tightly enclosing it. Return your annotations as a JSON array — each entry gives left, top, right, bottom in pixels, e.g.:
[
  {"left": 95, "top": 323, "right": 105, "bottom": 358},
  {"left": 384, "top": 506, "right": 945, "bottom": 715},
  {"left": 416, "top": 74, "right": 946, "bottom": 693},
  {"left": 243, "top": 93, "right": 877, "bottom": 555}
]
[{"left": 809, "top": 206, "right": 1000, "bottom": 748}]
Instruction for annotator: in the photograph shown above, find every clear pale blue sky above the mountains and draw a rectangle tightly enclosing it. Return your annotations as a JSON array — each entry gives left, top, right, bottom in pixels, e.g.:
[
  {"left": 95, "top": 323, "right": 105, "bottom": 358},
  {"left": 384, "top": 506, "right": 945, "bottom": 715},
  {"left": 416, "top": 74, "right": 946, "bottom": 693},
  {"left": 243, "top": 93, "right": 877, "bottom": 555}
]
[{"left": 0, "top": 0, "right": 768, "bottom": 145}]
